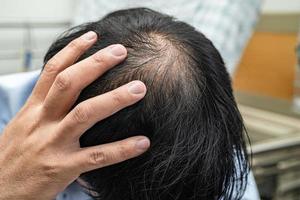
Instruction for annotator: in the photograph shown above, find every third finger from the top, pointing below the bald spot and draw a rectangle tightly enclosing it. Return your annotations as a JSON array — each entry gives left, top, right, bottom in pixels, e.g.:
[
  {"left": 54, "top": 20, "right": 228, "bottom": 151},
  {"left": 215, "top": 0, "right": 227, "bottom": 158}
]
[{"left": 60, "top": 81, "right": 146, "bottom": 141}]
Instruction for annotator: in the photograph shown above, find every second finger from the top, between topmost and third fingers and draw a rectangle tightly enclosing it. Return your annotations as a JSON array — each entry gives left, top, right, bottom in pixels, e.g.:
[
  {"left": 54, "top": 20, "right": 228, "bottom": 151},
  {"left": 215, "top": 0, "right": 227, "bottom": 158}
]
[{"left": 44, "top": 44, "right": 127, "bottom": 118}]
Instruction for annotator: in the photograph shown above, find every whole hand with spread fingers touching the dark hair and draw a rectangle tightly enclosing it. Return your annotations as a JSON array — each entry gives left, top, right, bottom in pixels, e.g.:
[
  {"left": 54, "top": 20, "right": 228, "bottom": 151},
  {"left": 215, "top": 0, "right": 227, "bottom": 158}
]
[{"left": 0, "top": 31, "right": 150, "bottom": 200}]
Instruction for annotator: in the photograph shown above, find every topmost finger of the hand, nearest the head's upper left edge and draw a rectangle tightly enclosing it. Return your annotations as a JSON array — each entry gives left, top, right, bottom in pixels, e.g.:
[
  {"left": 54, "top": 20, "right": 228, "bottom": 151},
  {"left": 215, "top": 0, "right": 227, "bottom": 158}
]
[{"left": 31, "top": 31, "right": 97, "bottom": 101}]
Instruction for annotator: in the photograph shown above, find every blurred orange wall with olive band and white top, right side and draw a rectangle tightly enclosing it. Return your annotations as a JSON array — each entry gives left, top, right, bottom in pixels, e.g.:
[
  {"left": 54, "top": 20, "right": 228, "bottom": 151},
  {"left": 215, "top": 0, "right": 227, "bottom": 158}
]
[{"left": 234, "top": 0, "right": 300, "bottom": 100}]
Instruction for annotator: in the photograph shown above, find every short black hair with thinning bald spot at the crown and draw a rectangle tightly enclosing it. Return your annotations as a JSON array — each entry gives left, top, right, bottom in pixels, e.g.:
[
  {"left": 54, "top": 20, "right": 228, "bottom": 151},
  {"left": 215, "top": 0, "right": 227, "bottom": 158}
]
[{"left": 44, "top": 8, "right": 249, "bottom": 200}]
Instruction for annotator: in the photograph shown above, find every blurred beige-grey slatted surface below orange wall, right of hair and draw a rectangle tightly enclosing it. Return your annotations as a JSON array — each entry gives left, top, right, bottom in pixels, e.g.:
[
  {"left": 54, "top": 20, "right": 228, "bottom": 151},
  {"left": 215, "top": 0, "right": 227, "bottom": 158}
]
[{"left": 236, "top": 93, "right": 300, "bottom": 200}]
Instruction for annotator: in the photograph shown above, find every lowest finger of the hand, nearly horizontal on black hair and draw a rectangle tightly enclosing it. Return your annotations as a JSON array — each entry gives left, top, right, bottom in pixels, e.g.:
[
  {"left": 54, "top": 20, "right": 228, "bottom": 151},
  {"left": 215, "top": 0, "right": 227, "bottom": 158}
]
[{"left": 71, "top": 136, "right": 150, "bottom": 173}]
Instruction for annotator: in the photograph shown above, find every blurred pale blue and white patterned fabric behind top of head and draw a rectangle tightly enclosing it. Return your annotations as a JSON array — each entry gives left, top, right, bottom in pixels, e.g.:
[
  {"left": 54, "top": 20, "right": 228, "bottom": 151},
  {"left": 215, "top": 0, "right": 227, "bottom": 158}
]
[{"left": 73, "top": 0, "right": 262, "bottom": 74}]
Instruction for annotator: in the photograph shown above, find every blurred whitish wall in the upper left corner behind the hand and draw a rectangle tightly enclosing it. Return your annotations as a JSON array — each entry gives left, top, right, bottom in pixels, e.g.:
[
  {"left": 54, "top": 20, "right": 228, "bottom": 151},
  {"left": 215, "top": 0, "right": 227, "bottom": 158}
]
[{"left": 0, "top": 0, "right": 76, "bottom": 74}]
